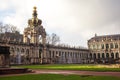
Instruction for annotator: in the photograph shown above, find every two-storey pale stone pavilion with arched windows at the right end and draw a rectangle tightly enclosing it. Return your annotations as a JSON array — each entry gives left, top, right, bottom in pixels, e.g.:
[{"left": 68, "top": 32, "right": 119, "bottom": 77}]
[{"left": 88, "top": 34, "right": 120, "bottom": 63}]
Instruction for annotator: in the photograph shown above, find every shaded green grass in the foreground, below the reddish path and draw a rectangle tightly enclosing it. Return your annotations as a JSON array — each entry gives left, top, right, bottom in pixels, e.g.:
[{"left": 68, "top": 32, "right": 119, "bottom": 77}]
[{"left": 0, "top": 74, "right": 120, "bottom": 80}]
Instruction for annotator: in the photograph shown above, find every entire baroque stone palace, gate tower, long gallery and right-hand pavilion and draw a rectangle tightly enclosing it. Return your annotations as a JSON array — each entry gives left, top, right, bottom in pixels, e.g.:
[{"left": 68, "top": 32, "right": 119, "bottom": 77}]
[{"left": 0, "top": 7, "right": 120, "bottom": 67}]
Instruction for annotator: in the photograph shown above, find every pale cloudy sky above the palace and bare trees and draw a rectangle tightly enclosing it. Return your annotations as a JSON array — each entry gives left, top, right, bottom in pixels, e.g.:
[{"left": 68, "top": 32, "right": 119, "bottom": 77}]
[{"left": 0, "top": 0, "right": 120, "bottom": 47}]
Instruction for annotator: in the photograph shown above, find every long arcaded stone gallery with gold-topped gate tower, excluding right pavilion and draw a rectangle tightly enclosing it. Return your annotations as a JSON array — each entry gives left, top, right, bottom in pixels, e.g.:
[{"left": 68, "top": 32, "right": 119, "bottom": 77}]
[{"left": 0, "top": 7, "right": 89, "bottom": 67}]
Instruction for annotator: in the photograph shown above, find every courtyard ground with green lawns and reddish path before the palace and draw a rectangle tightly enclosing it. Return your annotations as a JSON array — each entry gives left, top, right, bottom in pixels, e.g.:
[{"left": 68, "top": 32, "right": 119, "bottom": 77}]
[{"left": 0, "top": 64, "right": 120, "bottom": 80}]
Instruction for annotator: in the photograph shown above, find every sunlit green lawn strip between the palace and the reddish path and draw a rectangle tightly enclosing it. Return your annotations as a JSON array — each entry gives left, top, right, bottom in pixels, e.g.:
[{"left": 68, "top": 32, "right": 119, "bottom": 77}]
[{"left": 13, "top": 64, "right": 120, "bottom": 72}]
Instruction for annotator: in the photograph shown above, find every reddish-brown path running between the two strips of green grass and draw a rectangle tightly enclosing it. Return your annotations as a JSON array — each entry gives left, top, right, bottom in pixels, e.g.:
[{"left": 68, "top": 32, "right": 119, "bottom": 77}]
[{"left": 0, "top": 70, "right": 120, "bottom": 77}]
